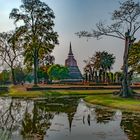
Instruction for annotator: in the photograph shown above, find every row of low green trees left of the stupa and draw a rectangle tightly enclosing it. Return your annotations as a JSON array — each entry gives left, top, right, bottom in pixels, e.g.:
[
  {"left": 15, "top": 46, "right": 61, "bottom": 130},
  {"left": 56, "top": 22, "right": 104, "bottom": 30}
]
[{"left": 0, "top": 64, "right": 69, "bottom": 85}]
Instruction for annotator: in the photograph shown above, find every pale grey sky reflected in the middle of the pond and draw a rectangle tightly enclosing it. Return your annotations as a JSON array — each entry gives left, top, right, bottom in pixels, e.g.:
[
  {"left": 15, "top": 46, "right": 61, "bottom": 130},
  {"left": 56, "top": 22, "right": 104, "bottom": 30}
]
[{"left": 45, "top": 99, "right": 127, "bottom": 140}]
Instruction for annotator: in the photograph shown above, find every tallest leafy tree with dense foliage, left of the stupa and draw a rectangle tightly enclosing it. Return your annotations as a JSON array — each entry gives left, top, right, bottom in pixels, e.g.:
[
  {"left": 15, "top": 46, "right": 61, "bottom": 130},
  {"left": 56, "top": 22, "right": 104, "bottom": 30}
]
[{"left": 10, "top": 0, "right": 58, "bottom": 85}]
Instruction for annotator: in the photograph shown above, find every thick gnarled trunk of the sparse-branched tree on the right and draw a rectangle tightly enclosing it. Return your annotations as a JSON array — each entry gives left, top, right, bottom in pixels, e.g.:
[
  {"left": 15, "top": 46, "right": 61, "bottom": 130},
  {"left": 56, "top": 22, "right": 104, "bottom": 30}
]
[{"left": 120, "top": 31, "right": 132, "bottom": 97}]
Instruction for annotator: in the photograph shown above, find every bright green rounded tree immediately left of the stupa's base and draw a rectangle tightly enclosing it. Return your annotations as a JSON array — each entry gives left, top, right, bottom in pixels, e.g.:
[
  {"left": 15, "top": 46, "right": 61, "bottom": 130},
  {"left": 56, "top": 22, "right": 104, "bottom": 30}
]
[{"left": 48, "top": 64, "right": 69, "bottom": 80}]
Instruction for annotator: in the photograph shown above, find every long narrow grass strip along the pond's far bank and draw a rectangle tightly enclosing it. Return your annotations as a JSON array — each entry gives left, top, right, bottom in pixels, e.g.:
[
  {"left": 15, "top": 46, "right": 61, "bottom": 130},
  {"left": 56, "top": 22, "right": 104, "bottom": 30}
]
[{"left": 8, "top": 86, "right": 115, "bottom": 98}]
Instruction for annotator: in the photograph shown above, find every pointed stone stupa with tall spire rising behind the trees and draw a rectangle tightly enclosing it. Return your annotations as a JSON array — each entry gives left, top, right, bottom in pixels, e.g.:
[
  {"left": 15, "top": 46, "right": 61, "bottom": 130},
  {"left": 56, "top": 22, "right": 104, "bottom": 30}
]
[{"left": 65, "top": 43, "right": 82, "bottom": 81}]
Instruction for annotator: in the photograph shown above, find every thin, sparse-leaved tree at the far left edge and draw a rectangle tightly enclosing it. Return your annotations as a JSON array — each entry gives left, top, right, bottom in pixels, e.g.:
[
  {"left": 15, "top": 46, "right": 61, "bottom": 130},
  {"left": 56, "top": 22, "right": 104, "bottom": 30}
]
[{"left": 0, "top": 30, "right": 23, "bottom": 84}]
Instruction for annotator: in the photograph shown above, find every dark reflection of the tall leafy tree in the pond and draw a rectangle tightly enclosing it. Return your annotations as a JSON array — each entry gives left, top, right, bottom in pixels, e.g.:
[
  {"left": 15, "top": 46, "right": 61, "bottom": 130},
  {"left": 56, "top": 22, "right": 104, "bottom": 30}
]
[{"left": 21, "top": 101, "right": 54, "bottom": 139}]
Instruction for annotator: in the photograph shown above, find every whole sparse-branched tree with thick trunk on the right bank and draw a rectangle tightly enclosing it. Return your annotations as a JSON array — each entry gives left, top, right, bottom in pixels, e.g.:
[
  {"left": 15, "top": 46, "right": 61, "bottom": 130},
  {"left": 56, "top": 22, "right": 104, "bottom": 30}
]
[{"left": 77, "top": 0, "right": 140, "bottom": 97}]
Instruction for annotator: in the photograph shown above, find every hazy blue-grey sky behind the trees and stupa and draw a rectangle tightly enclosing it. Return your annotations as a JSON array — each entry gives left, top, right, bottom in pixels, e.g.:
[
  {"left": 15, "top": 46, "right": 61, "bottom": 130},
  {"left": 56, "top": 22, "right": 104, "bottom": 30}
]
[{"left": 0, "top": 0, "right": 139, "bottom": 72}]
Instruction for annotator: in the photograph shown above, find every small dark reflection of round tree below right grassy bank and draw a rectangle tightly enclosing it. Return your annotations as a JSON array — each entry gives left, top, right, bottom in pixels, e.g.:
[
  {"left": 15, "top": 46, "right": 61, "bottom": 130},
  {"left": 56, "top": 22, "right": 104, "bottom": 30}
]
[{"left": 95, "top": 107, "right": 115, "bottom": 124}]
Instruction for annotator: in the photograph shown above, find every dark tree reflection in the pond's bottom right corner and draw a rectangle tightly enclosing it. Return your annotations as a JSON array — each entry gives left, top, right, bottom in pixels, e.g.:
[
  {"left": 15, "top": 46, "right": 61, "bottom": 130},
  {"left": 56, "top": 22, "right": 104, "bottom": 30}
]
[{"left": 121, "top": 112, "right": 140, "bottom": 140}]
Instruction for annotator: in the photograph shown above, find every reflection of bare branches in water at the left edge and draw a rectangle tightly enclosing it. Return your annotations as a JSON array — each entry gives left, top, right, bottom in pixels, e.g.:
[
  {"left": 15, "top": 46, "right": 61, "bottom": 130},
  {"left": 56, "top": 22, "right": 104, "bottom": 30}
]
[{"left": 0, "top": 99, "right": 25, "bottom": 140}]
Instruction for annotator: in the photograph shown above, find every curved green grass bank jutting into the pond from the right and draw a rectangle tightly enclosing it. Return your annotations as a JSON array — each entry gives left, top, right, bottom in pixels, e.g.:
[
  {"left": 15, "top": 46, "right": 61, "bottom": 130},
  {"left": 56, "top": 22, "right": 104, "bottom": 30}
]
[{"left": 85, "top": 95, "right": 140, "bottom": 111}]
